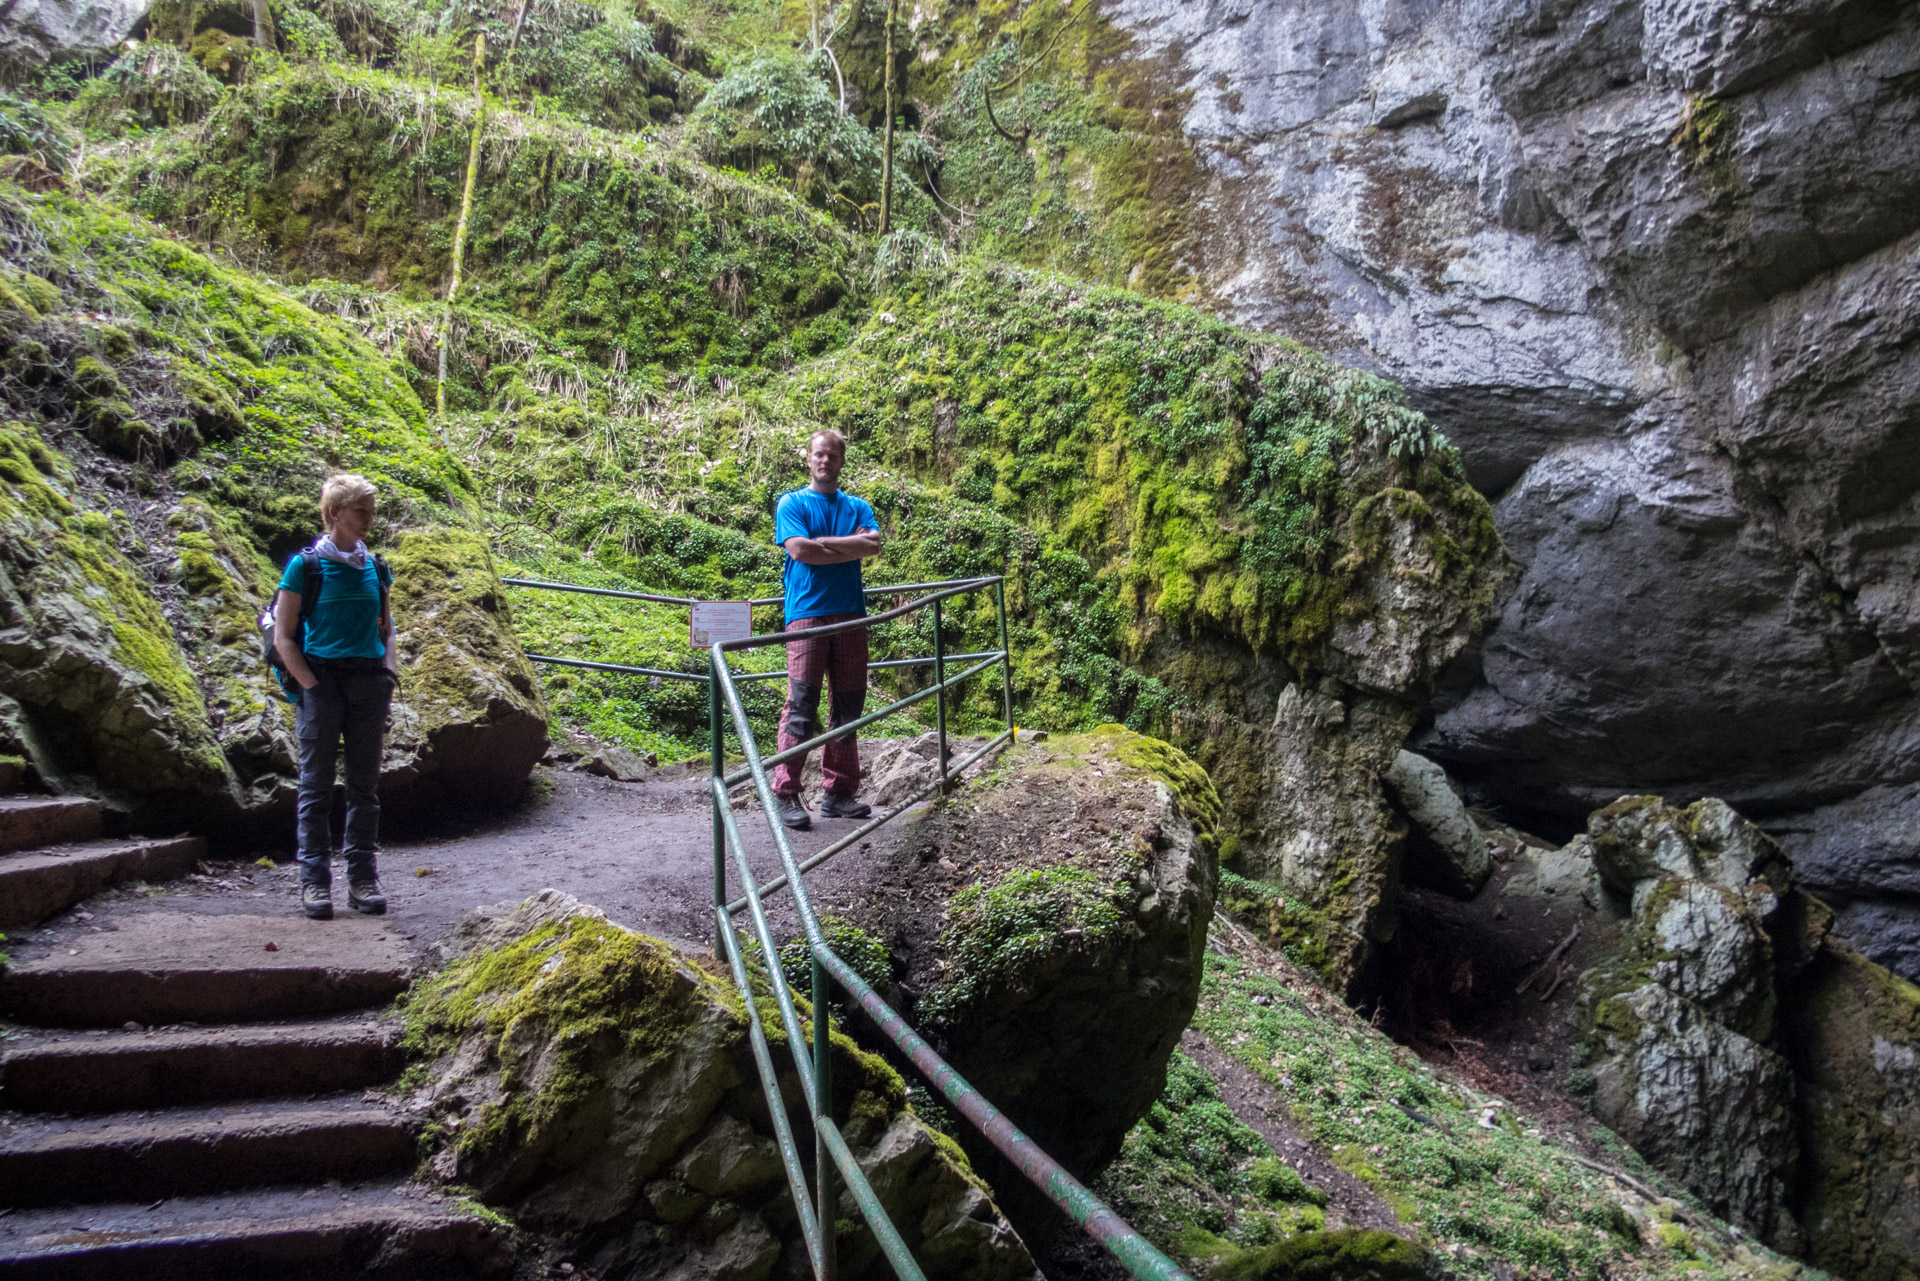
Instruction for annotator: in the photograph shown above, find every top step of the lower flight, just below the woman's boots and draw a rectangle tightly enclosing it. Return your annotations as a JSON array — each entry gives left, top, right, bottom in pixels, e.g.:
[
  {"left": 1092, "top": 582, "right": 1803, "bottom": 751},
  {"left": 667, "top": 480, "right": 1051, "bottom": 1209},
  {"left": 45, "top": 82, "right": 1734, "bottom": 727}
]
[{"left": 0, "top": 908, "right": 411, "bottom": 1029}]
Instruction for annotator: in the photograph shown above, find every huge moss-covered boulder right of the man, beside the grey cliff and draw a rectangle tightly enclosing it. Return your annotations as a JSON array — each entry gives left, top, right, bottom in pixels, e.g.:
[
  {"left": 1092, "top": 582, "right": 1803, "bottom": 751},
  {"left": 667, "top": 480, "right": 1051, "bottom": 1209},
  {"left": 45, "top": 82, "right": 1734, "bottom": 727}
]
[{"left": 795, "top": 263, "right": 1507, "bottom": 985}]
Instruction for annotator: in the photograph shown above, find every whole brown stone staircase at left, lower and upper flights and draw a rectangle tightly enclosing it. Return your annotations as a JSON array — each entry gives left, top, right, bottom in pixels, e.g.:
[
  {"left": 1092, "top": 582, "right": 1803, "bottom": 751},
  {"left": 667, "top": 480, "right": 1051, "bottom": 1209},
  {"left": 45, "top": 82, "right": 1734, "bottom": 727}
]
[{"left": 0, "top": 772, "right": 513, "bottom": 1281}]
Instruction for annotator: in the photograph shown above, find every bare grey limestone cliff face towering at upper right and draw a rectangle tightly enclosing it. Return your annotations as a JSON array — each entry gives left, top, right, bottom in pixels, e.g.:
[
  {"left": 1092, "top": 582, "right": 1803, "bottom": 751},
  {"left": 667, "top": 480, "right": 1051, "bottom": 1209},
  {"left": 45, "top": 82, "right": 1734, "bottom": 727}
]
[{"left": 1104, "top": 0, "right": 1920, "bottom": 971}]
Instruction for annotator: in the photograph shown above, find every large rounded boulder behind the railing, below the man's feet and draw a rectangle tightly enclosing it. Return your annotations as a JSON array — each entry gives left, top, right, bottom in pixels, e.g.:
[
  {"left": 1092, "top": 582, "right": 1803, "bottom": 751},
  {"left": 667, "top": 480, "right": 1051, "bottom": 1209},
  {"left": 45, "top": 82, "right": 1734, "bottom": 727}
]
[{"left": 849, "top": 726, "right": 1219, "bottom": 1233}]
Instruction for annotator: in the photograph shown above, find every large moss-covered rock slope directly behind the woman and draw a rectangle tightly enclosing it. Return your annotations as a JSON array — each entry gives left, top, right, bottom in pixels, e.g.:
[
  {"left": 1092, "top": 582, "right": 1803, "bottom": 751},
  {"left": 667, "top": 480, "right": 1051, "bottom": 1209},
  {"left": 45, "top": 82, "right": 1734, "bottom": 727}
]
[{"left": 0, "top": 186, "right": 545, "bottom": 835}]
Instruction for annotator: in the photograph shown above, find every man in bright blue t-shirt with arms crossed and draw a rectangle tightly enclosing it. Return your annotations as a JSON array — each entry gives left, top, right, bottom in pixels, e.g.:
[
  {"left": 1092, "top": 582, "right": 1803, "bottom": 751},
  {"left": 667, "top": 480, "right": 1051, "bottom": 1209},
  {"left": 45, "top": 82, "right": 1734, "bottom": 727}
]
[{"left": 774, "top": 430, "right": 879, "bottom": 830}]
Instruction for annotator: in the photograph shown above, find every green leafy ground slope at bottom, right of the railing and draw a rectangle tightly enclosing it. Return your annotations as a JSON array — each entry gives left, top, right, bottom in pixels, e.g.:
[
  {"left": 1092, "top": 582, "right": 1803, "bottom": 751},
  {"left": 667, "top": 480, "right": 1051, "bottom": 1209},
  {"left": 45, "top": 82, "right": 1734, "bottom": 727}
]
[{"left": 1096, "top": 931, "right": 1824, "bottom": 1281}]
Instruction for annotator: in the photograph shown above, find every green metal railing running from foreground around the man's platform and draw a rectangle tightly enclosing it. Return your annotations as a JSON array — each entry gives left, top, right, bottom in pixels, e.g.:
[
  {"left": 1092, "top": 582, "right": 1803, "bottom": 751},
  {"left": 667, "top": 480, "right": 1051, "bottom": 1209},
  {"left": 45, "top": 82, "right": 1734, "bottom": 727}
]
[{"left": 503, "top": 574, "right": 1192, "bottom": 1281}]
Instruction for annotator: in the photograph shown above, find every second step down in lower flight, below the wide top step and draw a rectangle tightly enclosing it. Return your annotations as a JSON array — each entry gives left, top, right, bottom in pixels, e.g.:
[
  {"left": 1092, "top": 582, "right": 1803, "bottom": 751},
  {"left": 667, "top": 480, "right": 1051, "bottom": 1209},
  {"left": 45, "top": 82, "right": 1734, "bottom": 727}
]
[{"left": 0, "top": 1018, "right": 403, "bottom": 1114}]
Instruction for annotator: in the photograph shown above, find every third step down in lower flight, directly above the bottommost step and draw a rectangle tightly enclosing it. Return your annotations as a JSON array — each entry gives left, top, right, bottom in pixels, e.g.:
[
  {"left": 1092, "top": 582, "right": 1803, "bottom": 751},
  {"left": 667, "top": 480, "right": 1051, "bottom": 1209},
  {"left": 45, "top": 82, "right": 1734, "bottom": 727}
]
[{"left": 0, "top": 1097, "right": 419, "bottom": 1206}]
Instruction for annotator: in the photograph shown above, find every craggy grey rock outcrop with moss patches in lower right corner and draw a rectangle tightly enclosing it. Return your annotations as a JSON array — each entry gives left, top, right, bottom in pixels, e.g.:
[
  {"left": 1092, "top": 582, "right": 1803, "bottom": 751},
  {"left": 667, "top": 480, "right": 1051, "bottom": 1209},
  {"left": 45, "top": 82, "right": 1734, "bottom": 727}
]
[{"left": 1563, "top": 797, "right": 1920, "bottom": 1281}]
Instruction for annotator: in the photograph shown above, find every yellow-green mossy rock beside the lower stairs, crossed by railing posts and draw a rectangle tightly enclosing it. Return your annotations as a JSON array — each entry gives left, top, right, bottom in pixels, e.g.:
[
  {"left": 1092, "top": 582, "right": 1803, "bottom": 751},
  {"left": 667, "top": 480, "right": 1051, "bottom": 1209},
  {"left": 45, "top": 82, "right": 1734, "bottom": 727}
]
[{"left": 407, "top": 889, "right": 1037, "bottom": 1281}]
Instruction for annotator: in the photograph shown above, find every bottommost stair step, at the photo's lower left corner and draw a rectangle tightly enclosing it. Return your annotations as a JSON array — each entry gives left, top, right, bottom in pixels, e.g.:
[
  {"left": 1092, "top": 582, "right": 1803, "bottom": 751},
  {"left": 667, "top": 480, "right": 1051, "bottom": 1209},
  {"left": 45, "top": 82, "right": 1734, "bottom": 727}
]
[{"left": 0, "top": 1183, "right": 513, "bottom": 1281}]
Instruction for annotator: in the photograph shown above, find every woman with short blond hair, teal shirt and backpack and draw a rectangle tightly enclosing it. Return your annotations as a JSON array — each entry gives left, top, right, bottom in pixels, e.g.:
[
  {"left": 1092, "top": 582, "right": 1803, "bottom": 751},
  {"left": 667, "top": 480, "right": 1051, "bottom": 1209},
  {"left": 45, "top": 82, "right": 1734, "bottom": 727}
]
[{"left": 273, "top": 474, "right": 397, "bottom": 920}]
